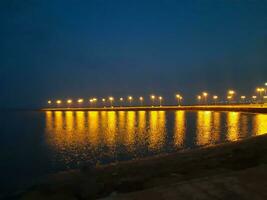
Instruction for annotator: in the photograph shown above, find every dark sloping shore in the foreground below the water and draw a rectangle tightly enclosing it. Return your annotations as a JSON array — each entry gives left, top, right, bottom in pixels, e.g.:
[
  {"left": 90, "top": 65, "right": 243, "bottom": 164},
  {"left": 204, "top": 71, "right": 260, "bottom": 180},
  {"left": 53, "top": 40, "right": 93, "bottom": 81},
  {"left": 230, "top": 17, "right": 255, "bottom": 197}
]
[{"left": 16, "top": 135, "right": 267, "bottom": 200}]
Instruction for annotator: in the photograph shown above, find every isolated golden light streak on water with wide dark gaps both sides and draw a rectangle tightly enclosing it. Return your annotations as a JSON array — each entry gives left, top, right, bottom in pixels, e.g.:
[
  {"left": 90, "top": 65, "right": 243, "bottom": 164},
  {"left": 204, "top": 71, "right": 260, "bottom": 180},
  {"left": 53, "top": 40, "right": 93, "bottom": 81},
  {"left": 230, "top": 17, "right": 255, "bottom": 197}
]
[{"left": 174, "top": 111, "right": 186, "bottom": 147}]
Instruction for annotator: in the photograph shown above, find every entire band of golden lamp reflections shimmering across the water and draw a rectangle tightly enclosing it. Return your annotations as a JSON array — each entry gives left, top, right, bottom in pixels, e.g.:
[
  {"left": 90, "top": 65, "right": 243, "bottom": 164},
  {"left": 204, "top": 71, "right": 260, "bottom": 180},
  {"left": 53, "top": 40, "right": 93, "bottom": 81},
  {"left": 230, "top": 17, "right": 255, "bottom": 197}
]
[{"left": 45, "top": 111, "right": 267, "bottom": 163}]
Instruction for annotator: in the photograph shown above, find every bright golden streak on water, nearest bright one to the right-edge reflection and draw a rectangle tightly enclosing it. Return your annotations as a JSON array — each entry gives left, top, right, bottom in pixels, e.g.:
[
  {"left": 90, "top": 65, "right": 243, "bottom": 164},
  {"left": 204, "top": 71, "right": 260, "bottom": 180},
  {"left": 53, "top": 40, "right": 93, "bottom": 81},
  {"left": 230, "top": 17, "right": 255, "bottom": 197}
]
[{"left": 227, "top": 112, "right": 240, "bottom": 141}]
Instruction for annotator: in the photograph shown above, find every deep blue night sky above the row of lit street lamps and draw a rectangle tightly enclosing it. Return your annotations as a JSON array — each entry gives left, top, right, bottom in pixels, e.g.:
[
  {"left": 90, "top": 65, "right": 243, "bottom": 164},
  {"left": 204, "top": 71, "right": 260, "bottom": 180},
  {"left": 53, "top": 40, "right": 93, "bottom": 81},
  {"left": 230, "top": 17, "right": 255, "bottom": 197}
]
[{"left": 0, "top": 0, "right": 267, "bottom": 108}]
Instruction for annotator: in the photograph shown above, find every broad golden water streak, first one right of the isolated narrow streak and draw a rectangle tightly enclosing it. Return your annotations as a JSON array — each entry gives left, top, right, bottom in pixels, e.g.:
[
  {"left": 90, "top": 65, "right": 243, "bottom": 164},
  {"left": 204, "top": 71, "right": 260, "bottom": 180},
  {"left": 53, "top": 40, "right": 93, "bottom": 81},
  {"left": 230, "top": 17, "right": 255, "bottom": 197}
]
[{"left": 196, "top": 111, "right": 211, "bottom": 146}]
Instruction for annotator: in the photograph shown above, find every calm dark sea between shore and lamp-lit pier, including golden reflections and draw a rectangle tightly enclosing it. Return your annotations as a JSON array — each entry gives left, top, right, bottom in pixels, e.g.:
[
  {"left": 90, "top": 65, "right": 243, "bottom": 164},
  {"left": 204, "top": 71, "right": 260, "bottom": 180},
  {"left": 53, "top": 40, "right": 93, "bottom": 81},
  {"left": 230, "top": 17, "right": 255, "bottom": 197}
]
[{"left": 0, "top": 111, "right": 267, "bottom": 197}]
